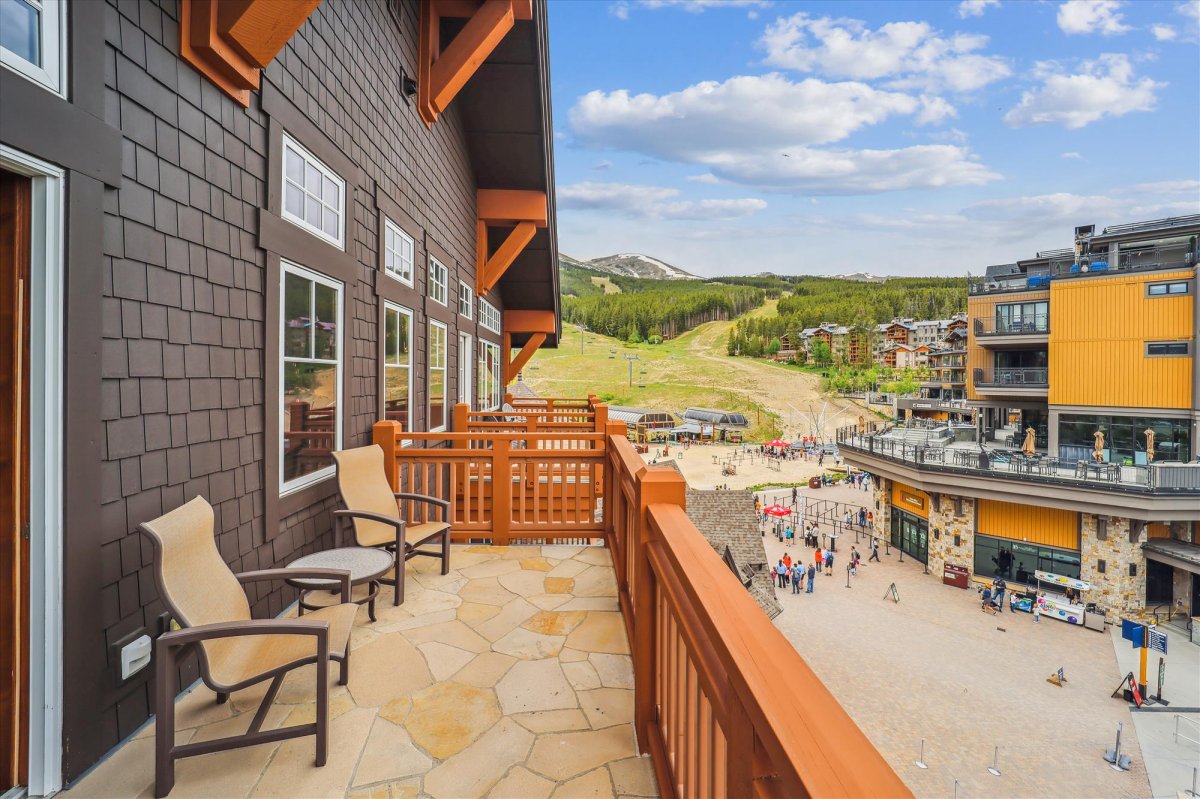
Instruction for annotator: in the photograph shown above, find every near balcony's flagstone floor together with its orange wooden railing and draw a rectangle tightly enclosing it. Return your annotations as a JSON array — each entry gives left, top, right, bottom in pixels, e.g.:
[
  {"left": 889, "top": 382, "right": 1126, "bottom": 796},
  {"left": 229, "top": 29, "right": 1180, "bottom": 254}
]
[{"left": 65, "top": 396, "right": 911, "bottom": 799}]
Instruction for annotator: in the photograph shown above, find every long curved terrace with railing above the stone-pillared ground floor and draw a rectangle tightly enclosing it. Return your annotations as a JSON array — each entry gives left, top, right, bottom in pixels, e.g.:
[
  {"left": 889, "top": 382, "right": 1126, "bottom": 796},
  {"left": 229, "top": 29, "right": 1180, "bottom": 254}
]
[{"left": 836, "top": 420, "right": 1200, "bottom": 519}]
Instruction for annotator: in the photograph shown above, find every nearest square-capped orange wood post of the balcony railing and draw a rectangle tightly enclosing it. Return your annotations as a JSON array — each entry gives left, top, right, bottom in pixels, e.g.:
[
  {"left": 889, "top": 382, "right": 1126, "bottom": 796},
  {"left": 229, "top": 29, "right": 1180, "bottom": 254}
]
[{"left": 629, "top": 467, "right": 691, "bottom": 753}]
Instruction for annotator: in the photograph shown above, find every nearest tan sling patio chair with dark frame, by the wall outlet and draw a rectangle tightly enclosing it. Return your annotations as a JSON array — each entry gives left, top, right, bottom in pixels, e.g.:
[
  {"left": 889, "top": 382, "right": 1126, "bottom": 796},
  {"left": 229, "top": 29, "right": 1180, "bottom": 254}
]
[{"left": 138, "top": 497, "right": 359, "bottom": 797}]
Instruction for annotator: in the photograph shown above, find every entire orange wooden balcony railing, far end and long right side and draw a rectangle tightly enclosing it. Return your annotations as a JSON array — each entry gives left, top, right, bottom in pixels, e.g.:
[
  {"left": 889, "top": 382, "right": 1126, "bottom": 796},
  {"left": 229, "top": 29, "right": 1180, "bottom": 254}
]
[{"left": 374, "top": 397, "right": 912, "bottom": 799}]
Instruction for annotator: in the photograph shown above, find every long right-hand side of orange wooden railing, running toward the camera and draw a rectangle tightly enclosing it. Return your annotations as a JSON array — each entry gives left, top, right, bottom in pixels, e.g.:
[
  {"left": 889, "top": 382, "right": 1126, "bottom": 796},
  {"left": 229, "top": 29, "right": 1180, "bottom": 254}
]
[{"left": 604, "top": 425, "right": 912, "bottom": 799}]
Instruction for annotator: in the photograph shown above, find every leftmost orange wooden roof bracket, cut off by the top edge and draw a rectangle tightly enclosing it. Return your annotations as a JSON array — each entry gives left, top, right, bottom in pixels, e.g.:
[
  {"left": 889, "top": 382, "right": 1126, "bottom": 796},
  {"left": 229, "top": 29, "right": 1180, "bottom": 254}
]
[{"left": 179, "top": 0, "right": 320, "bottom": 106}]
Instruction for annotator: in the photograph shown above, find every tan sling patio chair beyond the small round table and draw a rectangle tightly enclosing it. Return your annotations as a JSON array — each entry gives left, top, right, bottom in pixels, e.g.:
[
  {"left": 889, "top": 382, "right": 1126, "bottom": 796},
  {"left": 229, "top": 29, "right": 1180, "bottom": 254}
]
[{"left": 334, "top": 444, "right": 450, "bottom": 605}]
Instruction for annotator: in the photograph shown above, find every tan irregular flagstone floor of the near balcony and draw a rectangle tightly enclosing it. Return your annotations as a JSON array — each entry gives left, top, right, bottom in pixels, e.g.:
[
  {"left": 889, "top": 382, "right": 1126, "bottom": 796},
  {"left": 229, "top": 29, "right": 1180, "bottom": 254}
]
[{"left": 64, "top": 546, "right": 658, "bottom": 799}]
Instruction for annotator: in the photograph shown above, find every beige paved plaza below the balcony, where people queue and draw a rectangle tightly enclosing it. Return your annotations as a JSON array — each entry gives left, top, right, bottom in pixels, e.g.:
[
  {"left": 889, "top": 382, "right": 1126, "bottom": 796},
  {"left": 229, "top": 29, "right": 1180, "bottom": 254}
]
[{"left": 767, "top": 479, "right": 1161, "bottom": 799}]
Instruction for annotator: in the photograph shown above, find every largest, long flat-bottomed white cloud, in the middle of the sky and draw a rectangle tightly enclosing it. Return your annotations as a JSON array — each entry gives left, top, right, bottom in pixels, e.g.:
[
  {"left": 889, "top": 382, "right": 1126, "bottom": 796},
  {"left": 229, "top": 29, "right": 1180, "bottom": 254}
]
[{"left": 569, "top": 73, "right": 998, "bottom": 194}]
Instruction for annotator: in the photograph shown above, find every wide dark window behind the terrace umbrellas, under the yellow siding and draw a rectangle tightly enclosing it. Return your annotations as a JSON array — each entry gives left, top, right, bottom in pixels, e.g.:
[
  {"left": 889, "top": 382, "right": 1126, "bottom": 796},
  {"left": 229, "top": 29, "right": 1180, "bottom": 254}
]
[{"left": 1058, "top": 414, "right": 1192, "bottom": 464}]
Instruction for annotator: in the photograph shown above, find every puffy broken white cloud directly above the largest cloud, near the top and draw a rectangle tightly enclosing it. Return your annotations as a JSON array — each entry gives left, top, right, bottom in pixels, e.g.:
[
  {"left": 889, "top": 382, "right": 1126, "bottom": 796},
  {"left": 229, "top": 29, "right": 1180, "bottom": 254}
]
[{"left": 760, "top": 13, "right": 1012, "bottom": 92}]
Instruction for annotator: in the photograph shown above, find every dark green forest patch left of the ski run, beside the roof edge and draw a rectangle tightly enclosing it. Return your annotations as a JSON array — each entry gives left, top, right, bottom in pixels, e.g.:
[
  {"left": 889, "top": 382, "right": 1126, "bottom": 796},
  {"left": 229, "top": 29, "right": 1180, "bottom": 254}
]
[{"left": 559, "top": 257, "right": 764, "bottom": 341}]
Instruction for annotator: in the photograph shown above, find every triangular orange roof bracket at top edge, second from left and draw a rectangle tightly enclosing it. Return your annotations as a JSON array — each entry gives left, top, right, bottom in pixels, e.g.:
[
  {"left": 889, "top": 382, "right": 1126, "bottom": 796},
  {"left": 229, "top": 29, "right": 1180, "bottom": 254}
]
[{"left": 416, "top": 0, "right": 533, "bottom": 127}]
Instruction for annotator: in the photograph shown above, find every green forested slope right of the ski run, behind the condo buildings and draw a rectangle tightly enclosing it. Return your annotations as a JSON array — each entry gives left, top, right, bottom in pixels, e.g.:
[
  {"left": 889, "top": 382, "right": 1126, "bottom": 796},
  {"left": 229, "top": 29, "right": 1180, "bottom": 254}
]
[{"left": 722, "top": 276, "right": 967, "bottom": 354}]
